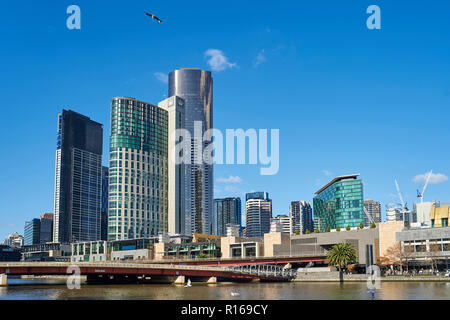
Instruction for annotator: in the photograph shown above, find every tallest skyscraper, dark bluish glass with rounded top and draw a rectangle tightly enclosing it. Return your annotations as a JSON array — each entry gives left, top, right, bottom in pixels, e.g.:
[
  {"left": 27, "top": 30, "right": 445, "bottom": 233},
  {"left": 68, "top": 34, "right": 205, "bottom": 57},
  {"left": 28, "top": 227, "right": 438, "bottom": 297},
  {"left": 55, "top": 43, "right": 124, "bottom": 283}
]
[{"left": 169, "top": 68, "right": 214, "bottom": 234}]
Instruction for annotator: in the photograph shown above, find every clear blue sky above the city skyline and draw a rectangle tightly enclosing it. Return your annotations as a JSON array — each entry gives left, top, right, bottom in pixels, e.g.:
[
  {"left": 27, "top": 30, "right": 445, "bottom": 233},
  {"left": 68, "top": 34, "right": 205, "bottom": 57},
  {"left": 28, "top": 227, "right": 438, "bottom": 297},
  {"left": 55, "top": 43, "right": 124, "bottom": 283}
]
[{"left": 0, "top": 0, "right": 450, "bottom": 239}]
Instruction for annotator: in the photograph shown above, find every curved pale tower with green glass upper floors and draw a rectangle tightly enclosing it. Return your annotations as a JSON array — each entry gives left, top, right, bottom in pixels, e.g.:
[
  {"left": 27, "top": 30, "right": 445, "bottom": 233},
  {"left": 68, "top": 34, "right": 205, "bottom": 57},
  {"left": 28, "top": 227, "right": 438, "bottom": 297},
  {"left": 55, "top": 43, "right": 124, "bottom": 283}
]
[{"left": 108, "top": 97, "right": 168, "bottom": 240}]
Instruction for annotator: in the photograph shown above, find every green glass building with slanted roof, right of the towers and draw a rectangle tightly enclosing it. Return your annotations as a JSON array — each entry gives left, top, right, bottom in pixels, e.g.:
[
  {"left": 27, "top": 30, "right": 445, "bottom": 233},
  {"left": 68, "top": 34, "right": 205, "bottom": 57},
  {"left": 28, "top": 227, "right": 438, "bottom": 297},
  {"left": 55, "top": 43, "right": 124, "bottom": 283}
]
[{"left": 313, "top": 174, "right": 364, "bottom": 232}]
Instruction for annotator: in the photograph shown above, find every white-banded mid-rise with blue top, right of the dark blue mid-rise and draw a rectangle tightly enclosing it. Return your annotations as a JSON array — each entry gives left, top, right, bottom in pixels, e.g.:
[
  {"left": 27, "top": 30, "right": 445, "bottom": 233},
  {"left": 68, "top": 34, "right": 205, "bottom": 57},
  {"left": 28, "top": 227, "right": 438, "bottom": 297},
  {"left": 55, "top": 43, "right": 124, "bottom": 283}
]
[{"left": 245, "top": 192, "right": 272, "bottom": 238}]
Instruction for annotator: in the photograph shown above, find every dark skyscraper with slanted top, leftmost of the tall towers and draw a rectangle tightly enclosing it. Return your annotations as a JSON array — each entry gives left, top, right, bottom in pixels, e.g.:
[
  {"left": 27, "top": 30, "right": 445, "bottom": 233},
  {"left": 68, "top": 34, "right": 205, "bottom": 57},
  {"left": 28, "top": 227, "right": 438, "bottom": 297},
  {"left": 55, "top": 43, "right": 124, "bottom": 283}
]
[{"left": 53, "top": 110, "right": 103, "bottom": 243}]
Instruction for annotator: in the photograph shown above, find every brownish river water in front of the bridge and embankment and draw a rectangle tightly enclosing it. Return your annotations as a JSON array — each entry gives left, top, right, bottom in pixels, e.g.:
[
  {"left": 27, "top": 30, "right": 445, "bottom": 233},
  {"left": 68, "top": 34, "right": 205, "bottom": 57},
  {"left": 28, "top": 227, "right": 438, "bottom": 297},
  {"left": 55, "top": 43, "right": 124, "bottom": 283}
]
[{"left": 0, "top": 279, "right": 450, "bottom": 300}]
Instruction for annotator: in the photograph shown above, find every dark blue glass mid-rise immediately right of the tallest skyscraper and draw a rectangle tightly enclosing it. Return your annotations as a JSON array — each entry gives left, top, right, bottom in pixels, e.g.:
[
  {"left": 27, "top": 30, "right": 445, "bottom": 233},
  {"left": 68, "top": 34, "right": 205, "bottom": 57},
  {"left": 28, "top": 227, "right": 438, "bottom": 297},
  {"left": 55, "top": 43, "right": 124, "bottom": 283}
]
[{"left": 212, "top": 197, "right": 242, "bottom": 236}]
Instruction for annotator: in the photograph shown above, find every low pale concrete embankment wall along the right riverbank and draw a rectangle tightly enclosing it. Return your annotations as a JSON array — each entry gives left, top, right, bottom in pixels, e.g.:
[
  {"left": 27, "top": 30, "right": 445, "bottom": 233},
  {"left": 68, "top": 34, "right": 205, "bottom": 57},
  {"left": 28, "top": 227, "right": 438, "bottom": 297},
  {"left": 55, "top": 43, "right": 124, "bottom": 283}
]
[{"left": 293, "top": 271, "right": 450, "bottom": 282}]
